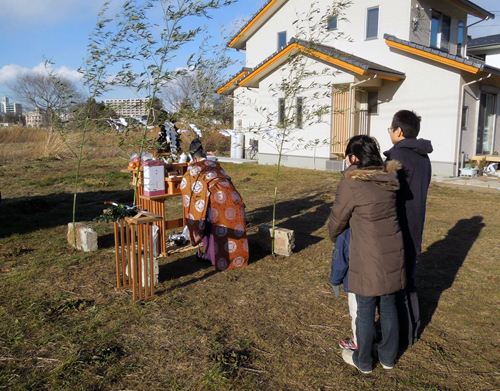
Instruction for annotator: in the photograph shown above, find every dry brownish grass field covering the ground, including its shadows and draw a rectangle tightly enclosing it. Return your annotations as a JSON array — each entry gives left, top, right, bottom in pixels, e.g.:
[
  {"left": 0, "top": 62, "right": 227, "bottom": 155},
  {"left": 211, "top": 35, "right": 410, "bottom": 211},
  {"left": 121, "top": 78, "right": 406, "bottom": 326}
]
[{"left": 0, "top": 128, "right": 500, "bottom": 391}]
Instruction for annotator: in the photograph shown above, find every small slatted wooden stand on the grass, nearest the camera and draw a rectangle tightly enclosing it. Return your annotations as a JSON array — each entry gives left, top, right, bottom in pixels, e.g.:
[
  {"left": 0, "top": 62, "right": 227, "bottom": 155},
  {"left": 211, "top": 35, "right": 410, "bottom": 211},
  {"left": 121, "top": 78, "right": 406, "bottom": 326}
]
[{"left": 115, "top": 211, "right": 162, "bottom": 300}]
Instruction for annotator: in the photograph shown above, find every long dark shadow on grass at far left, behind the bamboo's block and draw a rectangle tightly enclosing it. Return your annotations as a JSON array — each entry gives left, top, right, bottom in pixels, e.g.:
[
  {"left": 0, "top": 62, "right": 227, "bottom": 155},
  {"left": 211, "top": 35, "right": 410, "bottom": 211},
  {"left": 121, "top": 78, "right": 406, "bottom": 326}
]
[{"left": 0, "top": 190, "right": 133, "bottom": 240}]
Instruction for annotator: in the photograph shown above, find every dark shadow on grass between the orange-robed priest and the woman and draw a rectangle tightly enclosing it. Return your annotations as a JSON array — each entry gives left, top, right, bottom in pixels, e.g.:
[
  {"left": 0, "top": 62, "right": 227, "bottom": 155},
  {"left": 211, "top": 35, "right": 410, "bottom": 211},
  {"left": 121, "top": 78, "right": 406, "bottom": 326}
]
[{"left": 248, "top": 193, "right": 332, "bottom": 252}]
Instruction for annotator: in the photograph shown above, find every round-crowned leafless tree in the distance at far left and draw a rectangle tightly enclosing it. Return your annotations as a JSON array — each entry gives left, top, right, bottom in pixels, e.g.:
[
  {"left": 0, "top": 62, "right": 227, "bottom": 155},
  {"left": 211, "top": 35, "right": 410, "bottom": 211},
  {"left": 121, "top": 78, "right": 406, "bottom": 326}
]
[{"left": 8, "top": 72, "right": 81, "bottom": 122}]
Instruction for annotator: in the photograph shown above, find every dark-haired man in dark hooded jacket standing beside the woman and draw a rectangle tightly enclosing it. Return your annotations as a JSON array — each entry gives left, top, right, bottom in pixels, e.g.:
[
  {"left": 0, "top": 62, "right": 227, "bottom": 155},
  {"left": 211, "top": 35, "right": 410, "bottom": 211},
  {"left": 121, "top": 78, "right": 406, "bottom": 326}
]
[{"left": 384, "top": 110, "right": 432, "bottom": 349}]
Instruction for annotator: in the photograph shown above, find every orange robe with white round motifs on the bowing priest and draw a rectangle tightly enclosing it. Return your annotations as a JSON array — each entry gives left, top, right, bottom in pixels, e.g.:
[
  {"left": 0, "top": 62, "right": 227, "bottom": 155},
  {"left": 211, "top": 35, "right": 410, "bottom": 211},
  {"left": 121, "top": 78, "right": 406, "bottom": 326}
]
[{"left": 180, "top": 159, "right": 249, "bottom": 271}]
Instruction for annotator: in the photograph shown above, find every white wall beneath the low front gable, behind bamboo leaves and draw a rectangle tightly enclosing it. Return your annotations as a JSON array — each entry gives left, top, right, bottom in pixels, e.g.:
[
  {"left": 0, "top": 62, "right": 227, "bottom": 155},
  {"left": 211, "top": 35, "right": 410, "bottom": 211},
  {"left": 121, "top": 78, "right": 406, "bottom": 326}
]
[{"left": 241, "top": 60, "right": 354, "bottom": 170}]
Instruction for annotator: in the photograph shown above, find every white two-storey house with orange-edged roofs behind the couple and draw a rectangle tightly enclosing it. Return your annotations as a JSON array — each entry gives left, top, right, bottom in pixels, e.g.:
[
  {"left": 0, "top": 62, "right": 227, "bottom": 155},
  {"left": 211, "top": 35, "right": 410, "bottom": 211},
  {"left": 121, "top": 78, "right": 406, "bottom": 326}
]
[{"left": 218, "top": 0, "right": 500, "bottom": 175}]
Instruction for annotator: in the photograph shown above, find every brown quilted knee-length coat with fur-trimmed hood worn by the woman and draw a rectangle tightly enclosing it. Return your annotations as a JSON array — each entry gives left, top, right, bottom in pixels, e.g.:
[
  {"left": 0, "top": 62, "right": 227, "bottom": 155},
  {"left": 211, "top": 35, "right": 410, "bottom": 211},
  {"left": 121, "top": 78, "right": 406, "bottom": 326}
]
[{"left": 328, "top": 161, "right": 406, "bottom": 296}]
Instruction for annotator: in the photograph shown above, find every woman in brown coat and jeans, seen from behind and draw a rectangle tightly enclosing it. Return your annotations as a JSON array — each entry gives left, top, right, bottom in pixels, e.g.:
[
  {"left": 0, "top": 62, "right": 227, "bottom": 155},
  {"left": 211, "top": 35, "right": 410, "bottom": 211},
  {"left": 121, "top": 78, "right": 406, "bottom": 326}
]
[{"left": 329, "top": 135, "right": 406, "bottom": 373}]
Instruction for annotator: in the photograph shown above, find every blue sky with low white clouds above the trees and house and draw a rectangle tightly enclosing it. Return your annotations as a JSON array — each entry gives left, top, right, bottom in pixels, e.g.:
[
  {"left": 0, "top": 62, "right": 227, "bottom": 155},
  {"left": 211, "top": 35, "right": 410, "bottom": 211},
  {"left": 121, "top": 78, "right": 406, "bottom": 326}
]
[{"left": 0, "top": 0, "right": 500, "bottom": 103}]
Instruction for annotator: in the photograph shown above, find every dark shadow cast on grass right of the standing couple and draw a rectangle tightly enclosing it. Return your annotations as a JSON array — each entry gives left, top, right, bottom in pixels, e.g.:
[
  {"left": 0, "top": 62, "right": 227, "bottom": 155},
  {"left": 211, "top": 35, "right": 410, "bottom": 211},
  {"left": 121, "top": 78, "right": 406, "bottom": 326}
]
[{"left": 417, "top": 216, "right": 485, "bottom": 334}]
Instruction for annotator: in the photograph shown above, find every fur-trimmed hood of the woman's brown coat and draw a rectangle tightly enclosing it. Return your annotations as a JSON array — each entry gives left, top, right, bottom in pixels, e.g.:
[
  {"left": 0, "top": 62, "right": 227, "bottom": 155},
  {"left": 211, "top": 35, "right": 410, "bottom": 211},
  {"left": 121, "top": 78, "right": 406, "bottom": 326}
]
[{"left": 344, "top": 160, "right": 402, "bottom": 191}]
